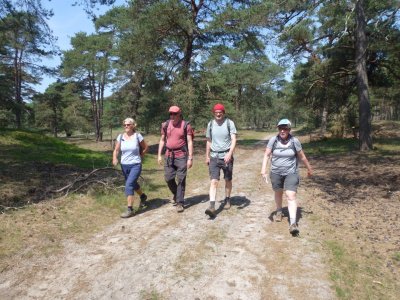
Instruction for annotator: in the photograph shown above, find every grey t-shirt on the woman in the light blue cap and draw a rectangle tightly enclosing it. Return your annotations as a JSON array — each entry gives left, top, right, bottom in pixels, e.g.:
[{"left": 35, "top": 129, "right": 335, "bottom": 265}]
[{"left": 267, "top": 136, "right": 302, "bottom": 176}]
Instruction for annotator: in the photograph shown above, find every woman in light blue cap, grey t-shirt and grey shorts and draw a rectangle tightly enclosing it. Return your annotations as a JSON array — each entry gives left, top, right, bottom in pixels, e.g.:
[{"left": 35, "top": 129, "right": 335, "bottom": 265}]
[{"left": 261, "top": 119, "right": 313, "bottom": 235}]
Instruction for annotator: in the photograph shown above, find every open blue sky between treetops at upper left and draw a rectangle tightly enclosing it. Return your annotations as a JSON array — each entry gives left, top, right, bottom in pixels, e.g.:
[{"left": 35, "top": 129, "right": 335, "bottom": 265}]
[{"left": 36, "top": 0, "right": 125, "bottom": 92}]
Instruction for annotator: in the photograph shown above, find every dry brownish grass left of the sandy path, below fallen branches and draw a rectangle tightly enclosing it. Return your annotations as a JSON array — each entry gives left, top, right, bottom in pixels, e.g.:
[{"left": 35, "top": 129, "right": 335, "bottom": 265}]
[{"left": 0, "top": 195, "right": 120, "bottom": 272}]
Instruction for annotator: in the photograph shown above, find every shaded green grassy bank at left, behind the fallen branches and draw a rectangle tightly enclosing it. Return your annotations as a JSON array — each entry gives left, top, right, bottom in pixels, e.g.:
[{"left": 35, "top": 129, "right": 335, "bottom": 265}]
[{"left": 0, "top": 129, "right": 110, "bottom": 168}]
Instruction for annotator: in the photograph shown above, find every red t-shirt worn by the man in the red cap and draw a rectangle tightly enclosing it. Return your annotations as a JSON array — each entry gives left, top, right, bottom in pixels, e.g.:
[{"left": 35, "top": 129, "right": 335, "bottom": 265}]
[{"left": 161, "top": 120, "right": 193, "bottom": 157}]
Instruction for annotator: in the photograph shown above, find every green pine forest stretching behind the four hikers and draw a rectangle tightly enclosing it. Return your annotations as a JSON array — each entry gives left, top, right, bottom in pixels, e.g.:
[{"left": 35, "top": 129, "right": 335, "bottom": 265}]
[{"left": 0, "top": 0, "right": 400, "bottom": 150}]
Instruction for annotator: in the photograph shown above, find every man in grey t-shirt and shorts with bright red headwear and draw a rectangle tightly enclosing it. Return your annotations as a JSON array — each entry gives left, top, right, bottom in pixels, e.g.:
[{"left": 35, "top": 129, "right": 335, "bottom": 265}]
[{"left": 205, "top": 103, "right": 237, "bottom": 218}]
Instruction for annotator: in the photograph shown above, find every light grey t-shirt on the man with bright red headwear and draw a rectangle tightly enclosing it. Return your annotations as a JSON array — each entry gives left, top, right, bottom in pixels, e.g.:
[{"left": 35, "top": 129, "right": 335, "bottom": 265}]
[{"left": 206, "top": 118, "right": 237, "bottom": 159}]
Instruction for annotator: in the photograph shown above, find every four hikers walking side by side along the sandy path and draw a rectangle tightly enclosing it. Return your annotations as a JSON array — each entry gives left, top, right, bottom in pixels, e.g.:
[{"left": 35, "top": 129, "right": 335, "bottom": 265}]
[{"left": 113, "top": 103, "right": 313, "bottom": 235}]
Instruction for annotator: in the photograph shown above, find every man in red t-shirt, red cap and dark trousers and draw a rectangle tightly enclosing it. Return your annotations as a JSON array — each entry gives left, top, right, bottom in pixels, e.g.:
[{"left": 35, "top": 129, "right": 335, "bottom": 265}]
[{"left": 158, "top": 106, "right": 193, "bottom": 212}]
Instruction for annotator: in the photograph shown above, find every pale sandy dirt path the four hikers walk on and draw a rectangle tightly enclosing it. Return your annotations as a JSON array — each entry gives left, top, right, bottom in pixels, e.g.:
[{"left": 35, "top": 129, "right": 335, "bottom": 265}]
[{"left": 0, "top": 138, "right": 335, "bottom": 300}]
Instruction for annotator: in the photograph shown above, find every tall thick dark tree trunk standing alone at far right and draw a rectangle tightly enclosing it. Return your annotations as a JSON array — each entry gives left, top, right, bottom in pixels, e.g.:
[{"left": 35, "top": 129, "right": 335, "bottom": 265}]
[{"left": 356, "top": 0, "right": 372, "bottom": 151}]
